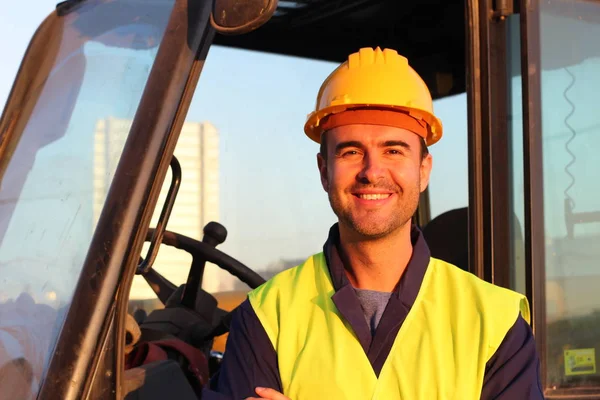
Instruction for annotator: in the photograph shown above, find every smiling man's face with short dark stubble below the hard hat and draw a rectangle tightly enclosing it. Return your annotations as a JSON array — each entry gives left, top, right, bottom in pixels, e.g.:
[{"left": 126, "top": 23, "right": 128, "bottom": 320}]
[{"left": 317, "top": 125, "right": 432, "bottom": 239}]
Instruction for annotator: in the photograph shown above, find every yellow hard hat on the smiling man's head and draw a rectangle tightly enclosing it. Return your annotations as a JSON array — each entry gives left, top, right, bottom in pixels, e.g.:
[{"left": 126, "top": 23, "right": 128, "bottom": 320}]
[{"left": 304, "top": 47, "right": 442, "bottom": 146}]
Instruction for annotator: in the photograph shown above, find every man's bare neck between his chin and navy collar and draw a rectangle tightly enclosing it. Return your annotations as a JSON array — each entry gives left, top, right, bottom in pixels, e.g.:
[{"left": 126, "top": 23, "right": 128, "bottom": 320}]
[{"left": 339, "top": 221, "right": 412, "bottom": 292}]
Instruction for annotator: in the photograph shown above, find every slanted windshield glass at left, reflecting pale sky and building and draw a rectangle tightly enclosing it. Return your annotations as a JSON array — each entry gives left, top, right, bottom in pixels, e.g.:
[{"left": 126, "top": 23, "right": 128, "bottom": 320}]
[{"left": 0, "top": 0, "right": 174, "bottom": 398}]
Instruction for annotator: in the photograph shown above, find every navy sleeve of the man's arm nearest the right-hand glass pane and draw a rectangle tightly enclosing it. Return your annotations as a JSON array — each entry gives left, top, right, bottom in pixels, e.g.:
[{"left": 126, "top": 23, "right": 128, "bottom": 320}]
[{"left": 481, "top": 316, "right": 544, "bottom": 400}]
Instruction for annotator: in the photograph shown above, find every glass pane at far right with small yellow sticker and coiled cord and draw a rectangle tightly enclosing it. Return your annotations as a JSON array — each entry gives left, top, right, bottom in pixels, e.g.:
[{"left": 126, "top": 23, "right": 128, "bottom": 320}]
[{"left": 540, "top": 0, "right": 600, "bottom": 388}]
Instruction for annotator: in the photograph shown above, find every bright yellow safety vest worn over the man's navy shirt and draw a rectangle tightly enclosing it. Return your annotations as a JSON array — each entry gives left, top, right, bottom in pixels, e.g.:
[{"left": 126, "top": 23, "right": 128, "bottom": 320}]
[{"left": 249, "top": 253, "right": 530, "bottom": 400}]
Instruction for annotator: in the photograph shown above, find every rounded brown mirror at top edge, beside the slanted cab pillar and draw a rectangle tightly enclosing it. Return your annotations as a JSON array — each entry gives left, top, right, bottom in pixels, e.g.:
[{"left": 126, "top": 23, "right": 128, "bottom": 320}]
[{"left": 210, "top": 0, "right": 278, "bottom": 35}]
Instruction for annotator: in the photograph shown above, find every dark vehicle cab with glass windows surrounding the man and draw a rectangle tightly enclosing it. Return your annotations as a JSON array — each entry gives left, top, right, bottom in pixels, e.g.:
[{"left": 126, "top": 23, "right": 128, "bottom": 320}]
[{"left": 0, "top": 0, "right": 600, "bottom": 399}]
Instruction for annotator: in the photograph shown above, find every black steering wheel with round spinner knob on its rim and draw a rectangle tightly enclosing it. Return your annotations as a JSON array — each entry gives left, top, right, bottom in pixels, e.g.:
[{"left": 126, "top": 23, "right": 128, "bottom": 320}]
[{"left": 136, "top": 222, "right": 265, "bottom": 309}]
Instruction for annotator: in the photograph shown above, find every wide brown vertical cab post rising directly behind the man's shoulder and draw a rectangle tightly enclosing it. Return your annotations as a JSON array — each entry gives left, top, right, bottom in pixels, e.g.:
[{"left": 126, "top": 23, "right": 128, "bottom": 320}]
[{"left": 465, "top": 0, "right": 514, "bottom": 287}]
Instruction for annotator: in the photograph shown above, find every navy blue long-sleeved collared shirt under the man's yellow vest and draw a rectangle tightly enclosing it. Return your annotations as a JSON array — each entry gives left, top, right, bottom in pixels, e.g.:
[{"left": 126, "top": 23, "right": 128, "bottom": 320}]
[{"left": 203, "top": 226, "right": 544, "bottom": 400}]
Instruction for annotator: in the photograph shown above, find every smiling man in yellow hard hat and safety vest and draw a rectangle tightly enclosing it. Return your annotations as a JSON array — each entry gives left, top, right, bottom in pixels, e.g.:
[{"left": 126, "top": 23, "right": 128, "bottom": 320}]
[{"left": 203, "top": 48, "right": 543, "bottom": 400}]
